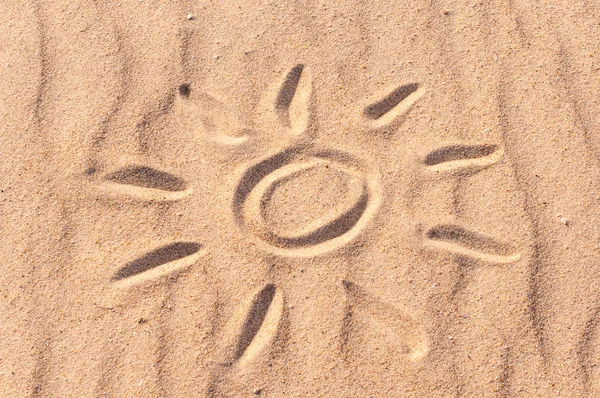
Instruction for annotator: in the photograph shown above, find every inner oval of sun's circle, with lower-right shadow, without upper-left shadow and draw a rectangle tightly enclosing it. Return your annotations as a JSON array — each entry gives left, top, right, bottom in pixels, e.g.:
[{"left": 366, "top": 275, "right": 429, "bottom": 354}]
[{"left": 241, "top": 159, "right": 368, "bottom": 247}]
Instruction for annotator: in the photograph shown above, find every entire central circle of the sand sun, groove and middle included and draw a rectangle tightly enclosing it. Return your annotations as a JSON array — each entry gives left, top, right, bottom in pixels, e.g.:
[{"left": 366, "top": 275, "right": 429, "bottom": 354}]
[{"left": 234, "top": 149, "right": 379, "bottom": 256}]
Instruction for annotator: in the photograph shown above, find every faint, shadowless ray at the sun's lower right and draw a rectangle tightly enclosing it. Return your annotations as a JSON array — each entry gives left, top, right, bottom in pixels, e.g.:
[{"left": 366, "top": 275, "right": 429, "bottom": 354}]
[{"left": 342, "top": 280, "right": 429, "bottom": 362}]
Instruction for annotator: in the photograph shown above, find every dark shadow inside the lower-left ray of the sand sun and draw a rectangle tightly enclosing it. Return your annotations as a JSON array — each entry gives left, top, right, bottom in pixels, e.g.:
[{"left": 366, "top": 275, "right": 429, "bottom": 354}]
[{"left": 112, "top": 242, "right": 202, "bottom": 281}]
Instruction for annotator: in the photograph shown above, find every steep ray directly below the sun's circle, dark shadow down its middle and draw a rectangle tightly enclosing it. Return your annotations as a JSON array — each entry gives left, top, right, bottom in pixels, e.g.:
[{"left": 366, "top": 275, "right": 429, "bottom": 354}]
[{"left": 221, "top": 284, "right": 283, "bottom": 368}]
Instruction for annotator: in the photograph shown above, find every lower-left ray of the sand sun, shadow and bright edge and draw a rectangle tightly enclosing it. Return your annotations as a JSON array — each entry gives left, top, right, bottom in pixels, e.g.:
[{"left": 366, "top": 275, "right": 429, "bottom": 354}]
[{"left": 111, "top": 242, "right": 203, "bottom": 285}]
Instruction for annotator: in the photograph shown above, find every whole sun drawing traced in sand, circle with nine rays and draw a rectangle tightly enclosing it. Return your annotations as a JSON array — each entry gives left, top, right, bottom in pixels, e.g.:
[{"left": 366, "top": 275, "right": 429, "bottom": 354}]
[{"left": 98, "top": 64, "right": 520, "bottom": 388}]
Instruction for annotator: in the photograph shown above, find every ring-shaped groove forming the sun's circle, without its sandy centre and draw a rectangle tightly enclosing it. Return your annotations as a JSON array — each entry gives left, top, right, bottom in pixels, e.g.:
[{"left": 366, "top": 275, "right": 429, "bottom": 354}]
[{"left": 233, "top": 148, "right": 381, "bottom": 257}]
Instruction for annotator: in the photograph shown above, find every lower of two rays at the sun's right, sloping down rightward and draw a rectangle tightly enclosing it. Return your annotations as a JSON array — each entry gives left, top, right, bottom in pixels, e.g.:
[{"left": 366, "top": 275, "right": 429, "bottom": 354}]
[{"left": 426, "top": 224, "right": 521, "bottom": 264}]
